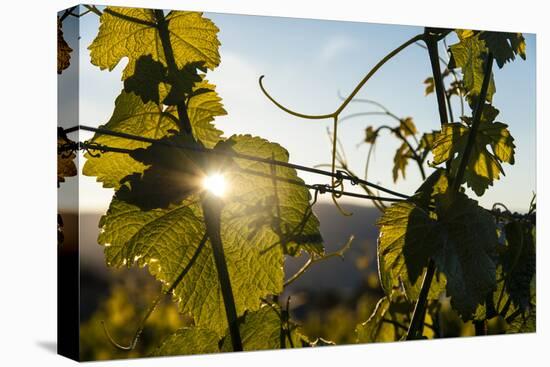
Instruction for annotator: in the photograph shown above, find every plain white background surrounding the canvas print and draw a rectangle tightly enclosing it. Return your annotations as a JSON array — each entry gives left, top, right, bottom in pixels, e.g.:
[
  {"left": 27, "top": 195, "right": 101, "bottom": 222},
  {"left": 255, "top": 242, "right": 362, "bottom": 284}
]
[{"left": 0, "top": 0, "right": 550, "bottom": 366}]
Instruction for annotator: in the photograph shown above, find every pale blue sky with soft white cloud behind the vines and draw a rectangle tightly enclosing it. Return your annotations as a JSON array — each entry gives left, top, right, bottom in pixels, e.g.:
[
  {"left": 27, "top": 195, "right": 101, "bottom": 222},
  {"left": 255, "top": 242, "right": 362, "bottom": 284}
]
[{"left": 60, "top": 6, "right": 536, "bottom": 210}]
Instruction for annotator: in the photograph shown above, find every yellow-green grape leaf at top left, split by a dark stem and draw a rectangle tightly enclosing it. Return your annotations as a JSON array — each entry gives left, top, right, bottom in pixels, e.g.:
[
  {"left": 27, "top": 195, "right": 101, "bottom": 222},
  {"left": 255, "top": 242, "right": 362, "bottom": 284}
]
[{"left": 88, "top": 7, "right": 220, "bottom": 79}]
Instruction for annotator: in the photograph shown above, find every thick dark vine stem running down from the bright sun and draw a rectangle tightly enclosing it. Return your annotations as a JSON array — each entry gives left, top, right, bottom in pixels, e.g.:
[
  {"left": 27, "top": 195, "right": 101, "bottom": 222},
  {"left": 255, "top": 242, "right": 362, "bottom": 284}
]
[{"left": 202, "top": 193, "right": 243, "bottom": 352}]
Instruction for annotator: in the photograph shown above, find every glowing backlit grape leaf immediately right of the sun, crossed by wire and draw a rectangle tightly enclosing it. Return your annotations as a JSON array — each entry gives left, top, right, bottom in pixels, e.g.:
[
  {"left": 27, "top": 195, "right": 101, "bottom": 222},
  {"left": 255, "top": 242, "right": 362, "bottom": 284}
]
[{"left": 211, "top": 135, "right": 324, "bottom": 256}]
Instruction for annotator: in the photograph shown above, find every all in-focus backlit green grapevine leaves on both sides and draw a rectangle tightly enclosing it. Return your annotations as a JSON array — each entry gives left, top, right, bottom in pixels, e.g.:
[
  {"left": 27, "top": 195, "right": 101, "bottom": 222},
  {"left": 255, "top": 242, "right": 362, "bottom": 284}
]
[{"left": 58, "top": 7, "right": 536, "bottom": 355}]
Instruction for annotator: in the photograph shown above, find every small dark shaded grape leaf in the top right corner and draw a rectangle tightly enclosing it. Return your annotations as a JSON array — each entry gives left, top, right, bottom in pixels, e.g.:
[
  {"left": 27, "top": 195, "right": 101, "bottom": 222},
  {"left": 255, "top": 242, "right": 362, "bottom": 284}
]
[{"left": 479, "top": 31, "right": 526, "bottom": 68}]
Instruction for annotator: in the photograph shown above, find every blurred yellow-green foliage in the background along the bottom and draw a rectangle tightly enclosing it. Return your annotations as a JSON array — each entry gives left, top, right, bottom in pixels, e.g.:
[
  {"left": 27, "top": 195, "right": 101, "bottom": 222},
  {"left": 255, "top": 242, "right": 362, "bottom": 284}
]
[{"left": 80, "top": 242, "right": 516, "bottom": 360}]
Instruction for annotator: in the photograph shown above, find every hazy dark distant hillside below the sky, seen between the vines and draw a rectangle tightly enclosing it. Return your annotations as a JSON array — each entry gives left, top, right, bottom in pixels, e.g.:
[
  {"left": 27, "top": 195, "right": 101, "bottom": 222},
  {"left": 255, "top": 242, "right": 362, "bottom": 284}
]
[{"left": 62, "top": 203, "right": 380, "bottom": 319}]
